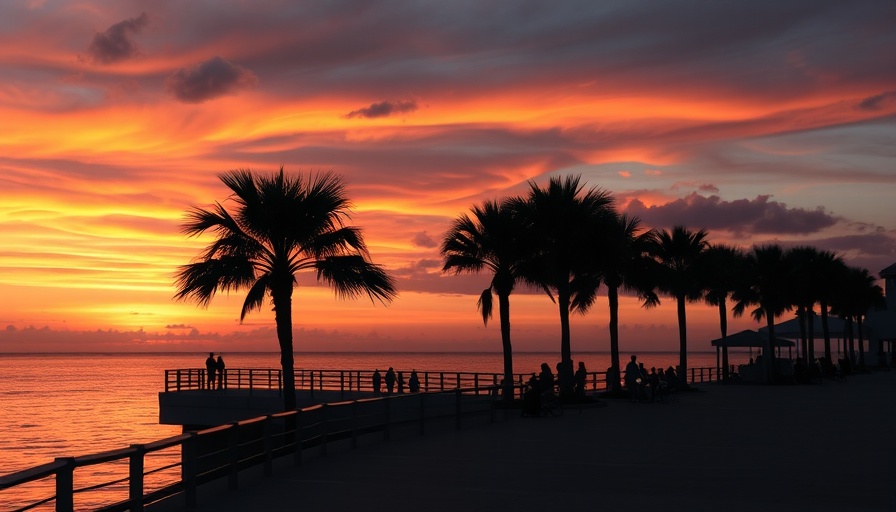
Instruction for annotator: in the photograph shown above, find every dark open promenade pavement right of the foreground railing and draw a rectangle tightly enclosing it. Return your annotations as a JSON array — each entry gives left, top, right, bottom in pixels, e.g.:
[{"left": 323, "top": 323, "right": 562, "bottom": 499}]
[{"left": 150, "top": 372, "right": 896, "bottom": 512}]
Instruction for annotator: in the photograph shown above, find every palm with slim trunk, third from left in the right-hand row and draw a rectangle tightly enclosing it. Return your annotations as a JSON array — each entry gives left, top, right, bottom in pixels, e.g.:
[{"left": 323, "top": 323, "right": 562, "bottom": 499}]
[{"left": 598, "top": 214, "right": 659, "bottom": 391}]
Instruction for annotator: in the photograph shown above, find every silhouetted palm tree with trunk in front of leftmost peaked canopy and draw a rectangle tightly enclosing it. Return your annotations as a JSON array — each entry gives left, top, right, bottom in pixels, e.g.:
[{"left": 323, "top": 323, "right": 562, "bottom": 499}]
[{"left": 733, "top": 245, "right": 792, "bottom": 382}]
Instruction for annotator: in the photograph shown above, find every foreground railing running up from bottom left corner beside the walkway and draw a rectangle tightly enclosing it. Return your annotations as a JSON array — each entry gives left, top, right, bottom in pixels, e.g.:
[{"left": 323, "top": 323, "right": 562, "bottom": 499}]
[{"left": 0, "top": 387, "right": 504, "bottom": 512}]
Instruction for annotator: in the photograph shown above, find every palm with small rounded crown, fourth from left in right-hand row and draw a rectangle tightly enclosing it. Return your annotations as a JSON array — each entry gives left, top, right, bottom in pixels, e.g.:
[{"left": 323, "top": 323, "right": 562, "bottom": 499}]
[{"left": 651, "top": 226, "right": 709, "bottom": 383}]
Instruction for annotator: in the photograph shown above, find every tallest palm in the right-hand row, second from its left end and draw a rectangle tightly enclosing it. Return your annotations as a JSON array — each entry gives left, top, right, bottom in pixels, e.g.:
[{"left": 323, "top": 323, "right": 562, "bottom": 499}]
[{"left": 512, "top": 176, "right": 614, "bottom": 396}]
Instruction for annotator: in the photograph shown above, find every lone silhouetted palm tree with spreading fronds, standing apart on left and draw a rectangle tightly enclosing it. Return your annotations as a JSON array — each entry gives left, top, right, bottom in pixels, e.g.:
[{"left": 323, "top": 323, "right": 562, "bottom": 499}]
[{"left": 175, "top": 167, "right": 395, "bottom": 410}]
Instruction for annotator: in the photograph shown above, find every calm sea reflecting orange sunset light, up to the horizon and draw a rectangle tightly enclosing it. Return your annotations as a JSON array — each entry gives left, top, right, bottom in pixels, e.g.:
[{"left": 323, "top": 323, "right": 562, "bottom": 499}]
[{"left": 0, "top": 353, "right": 749, "bottom": 510}]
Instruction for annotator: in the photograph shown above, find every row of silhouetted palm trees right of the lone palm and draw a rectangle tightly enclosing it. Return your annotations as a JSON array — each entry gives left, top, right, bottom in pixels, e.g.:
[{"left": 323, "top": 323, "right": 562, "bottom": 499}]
[{"left": 441, "top": 176, "right": 883, "bottom": 396}]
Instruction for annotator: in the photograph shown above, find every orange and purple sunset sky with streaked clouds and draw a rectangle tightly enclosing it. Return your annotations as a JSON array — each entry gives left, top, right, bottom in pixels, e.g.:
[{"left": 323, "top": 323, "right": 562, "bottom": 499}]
[{"left": 0, "top": 0, "right": 896, "bottom": 356}]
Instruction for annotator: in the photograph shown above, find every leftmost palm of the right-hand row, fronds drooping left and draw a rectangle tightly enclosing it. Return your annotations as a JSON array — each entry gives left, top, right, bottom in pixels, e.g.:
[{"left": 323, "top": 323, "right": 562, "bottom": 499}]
[{"left": 441, "top": 201, "right": 527, "bottom": 401}]
